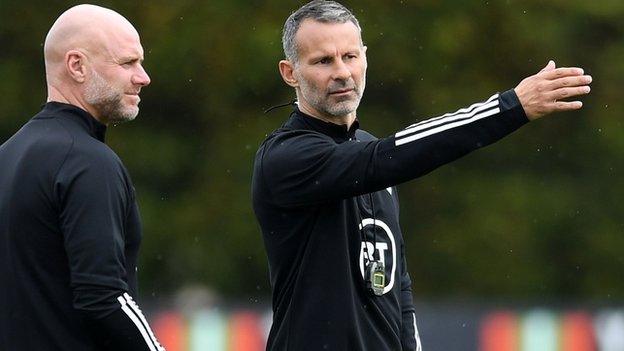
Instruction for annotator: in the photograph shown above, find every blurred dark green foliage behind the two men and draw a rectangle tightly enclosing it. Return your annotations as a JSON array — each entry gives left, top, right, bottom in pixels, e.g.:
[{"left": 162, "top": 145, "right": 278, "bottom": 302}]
[{"left": 0, "top": 0, "right": 624, "bottom": 303}]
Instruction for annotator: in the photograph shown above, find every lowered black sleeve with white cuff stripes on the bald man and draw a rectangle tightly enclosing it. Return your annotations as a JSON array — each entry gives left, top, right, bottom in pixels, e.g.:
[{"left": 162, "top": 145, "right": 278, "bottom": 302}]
[{"left": 55, "top": 148, "right": 163, "bottom": 351}]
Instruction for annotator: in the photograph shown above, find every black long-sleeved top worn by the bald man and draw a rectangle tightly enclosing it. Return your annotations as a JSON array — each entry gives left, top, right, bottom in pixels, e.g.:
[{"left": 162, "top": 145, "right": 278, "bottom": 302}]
[{"left": 0, "top": 102, "right": 160, "bottom": 351}]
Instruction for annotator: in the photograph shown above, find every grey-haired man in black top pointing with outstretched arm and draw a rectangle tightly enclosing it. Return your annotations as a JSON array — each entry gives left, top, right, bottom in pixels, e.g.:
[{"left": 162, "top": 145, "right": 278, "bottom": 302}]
[{"left": 252, "top": 1, "right": 591, "bottom": 351}]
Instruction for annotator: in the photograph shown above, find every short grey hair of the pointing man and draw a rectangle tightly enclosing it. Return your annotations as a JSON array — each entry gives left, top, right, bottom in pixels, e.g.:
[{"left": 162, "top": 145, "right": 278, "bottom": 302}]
[{"left": 282, "top": 0, "right": 362, "bottom": 63}]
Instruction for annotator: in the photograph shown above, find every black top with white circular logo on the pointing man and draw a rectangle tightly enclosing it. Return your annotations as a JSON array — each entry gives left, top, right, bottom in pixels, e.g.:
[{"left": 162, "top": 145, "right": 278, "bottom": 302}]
[{"left": 252, "top": 90, "right": 528, "bottom": 351}]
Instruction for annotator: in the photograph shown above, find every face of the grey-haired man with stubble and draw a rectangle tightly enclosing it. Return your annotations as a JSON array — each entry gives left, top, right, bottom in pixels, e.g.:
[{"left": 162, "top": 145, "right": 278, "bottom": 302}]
[{"left": 293, "top": 19, "right": 366, "bottom": 120}]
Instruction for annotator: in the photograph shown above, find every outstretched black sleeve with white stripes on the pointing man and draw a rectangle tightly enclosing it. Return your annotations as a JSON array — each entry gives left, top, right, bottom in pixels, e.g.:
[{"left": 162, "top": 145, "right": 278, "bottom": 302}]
[{"left": 259, "top": 90, "right": 528, "bottom": 206}]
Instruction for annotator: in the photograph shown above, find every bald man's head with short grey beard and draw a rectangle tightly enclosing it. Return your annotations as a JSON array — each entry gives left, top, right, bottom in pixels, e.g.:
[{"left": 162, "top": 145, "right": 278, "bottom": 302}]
[{"left": 44, "top": 4, "right": 149, "bottom": 123}]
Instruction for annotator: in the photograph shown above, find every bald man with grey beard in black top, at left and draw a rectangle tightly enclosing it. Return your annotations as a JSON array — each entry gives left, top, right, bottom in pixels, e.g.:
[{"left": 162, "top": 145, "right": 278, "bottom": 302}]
[{"left": 0, "top": 5, "right": 164, "bottom": 351}]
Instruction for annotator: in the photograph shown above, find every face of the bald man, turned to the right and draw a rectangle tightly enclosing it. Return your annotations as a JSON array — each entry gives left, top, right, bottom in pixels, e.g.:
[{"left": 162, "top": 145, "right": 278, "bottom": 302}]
[{"left": 84, "top": 31, "right": 150, "bottom": 123}]
